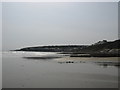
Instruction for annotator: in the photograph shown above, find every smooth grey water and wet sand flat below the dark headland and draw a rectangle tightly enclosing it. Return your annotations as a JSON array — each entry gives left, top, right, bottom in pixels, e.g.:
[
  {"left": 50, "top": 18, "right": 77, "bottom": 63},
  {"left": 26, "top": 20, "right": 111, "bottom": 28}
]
[{"left": 2, "top": 52, "right": 119, "bottom": 88}]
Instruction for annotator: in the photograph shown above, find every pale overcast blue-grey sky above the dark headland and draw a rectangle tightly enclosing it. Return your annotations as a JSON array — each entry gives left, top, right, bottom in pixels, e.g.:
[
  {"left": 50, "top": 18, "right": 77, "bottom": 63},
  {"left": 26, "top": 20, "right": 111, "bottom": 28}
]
[{"left": 2, "top": 2, "right": 118, "bottom": 50}]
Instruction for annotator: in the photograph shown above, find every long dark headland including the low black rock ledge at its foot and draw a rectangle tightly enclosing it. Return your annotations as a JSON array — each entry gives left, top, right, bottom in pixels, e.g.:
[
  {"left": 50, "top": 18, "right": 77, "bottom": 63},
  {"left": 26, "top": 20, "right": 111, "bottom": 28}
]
[{"left": 12, "top": 39, "right": 120, "bottom": 57}]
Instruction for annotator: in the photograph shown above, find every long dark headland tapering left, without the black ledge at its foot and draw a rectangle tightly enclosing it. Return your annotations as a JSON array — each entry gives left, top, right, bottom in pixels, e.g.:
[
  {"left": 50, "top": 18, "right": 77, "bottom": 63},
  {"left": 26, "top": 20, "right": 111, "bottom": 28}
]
[{"left": 15, "top": 40, "right": 120, "bottom": 54}]
